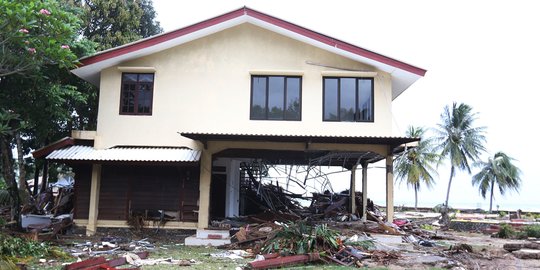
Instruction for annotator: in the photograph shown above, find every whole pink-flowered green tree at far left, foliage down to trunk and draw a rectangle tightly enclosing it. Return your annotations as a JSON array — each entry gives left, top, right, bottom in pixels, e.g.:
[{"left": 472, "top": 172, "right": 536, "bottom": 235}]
[{"left": 0, "top": 0, "right": 79, "bottom": 230}]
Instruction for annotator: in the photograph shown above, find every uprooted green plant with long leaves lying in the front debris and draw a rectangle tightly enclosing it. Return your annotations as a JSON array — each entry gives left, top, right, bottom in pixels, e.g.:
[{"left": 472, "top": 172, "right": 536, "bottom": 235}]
[{"left": 262, "top": 222, "right": 339, "bottom": 255}]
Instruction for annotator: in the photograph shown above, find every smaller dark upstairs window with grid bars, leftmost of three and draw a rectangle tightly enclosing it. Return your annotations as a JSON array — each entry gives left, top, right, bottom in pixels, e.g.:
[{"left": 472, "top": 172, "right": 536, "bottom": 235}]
[{"left": 120, "top": 73, "right": 154, "bottom": 115}]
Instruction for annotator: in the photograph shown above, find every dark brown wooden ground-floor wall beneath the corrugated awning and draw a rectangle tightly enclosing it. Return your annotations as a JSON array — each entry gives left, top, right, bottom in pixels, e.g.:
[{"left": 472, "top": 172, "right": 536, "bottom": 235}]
[{"left": 80, "top": 165, "right": 199, "bottom": 223}]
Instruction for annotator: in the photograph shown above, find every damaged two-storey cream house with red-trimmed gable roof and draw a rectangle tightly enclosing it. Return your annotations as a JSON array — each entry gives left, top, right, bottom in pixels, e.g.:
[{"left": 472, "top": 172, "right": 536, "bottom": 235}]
[{"left": 34, "top": 7, "right": 426, "bottom": 237}]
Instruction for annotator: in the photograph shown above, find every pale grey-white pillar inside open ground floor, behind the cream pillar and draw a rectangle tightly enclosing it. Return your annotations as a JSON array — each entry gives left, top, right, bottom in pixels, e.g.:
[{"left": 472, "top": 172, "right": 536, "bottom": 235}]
[{"left": 225, "top": 159, "right": 240, "bottom": 217}]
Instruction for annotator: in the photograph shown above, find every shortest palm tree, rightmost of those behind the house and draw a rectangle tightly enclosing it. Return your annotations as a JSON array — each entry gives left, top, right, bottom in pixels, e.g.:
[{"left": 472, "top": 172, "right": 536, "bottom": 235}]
[{"left": 472, "top": 152, "right": 521, "bottom": 213}]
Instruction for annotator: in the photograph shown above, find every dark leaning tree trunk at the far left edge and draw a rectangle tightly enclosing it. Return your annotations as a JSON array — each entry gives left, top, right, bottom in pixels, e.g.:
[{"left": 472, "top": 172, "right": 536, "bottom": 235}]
[{"left": 0, "top": 136, "right": 22, "bottom": 230}]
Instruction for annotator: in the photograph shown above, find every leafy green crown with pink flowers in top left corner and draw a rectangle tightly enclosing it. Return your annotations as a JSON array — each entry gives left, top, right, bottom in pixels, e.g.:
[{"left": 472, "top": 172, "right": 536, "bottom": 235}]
[{"left": 0, "top": 0, "right": 79, "bottom": 79}]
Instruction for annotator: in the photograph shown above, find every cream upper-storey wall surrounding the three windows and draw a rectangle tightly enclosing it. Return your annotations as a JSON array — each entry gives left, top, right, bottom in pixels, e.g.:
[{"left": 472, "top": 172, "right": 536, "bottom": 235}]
[{"left": 96, "top": 24, "right": 392, "bottom": 148}]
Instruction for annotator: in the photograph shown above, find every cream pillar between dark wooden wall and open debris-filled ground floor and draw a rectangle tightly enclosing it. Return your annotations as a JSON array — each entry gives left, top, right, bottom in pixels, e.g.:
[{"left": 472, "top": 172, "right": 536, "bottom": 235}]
[{"left": 197, "top": 150, "right": 212, "bottom": 229}]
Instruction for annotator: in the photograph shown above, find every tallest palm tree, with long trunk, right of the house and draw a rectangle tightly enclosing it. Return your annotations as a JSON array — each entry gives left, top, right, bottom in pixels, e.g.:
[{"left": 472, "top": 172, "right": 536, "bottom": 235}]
[{"left": 435, "top": 102, "right": 486, "bottom": 209}]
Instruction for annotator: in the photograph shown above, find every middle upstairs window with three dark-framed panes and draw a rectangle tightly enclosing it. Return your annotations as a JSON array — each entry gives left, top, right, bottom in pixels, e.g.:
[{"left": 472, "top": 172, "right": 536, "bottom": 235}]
[{"left": 250, "top": 76, "right": 302, "bottom": 121}]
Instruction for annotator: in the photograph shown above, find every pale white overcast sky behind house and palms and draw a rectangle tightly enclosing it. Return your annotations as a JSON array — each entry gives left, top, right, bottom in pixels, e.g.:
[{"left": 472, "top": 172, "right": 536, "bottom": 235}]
[{"left": 154, "top": 0, "right": 540, "bottom": 211}]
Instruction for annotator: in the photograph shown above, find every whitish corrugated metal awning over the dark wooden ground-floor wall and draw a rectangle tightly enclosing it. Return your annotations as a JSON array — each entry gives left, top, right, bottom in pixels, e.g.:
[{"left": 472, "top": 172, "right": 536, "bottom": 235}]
[{"left": 46, "top": 145, "right": 201, "bottom": 162}]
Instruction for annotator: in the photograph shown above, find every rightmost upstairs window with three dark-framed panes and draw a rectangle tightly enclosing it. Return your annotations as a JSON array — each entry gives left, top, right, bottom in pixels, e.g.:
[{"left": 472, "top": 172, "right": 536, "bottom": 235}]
[{"left": 323, "top": 77, "right": 374, "bottom": 122}]
